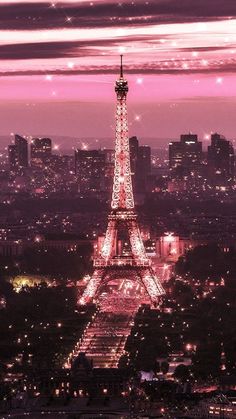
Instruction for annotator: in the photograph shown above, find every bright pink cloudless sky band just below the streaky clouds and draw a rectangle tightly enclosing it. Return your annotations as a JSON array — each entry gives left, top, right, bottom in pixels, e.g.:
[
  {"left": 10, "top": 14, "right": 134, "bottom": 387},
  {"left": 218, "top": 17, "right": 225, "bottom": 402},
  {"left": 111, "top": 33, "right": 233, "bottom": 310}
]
[{"left": 0, "top": 73, "right": 236, "bottom": 103}]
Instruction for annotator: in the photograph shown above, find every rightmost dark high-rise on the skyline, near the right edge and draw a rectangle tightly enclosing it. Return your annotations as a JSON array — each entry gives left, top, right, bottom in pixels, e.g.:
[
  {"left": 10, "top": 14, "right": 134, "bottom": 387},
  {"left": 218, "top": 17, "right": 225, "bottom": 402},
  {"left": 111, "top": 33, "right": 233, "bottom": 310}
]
[{"left": 207, "top": 133, "right": 234, "bottom": 187}]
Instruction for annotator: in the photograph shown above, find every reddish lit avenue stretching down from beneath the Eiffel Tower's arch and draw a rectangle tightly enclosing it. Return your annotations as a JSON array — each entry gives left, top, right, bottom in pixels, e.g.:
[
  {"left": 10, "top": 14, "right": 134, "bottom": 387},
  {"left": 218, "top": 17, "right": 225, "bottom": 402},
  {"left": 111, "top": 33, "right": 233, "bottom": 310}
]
[{"left": 68, "top": 280, "right": 148, "bottom": 368}]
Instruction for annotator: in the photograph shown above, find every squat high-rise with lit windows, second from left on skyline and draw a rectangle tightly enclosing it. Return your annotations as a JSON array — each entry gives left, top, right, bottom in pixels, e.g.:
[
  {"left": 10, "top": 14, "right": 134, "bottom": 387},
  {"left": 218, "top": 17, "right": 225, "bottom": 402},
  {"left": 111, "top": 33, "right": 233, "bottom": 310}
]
[{"left": 30, "top": 138, "right": 52, "bottom": 169}]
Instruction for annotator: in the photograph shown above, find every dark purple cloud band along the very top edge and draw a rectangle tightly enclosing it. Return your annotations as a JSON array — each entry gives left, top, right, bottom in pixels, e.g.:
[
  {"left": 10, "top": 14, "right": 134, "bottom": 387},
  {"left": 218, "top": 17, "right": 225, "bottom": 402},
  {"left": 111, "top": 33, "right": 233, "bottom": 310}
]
[{"left": 0, "top": 0, "right": 236, "bottom": 30}]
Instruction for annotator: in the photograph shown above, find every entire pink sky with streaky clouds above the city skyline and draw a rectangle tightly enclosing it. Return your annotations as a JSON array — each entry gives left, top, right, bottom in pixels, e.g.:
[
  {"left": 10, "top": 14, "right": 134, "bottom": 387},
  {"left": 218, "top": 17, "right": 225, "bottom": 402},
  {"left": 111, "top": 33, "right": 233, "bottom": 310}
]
[{"left": 0, "top": 0, "right": 236, "bottom": 147}]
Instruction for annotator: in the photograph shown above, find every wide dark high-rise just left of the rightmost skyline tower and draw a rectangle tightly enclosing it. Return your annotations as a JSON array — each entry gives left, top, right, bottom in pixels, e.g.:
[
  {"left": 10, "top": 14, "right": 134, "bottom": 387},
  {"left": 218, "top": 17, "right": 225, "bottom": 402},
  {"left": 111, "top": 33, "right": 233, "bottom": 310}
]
[{"left": 169, "top": 134, "right": 202, "bottom": 178}]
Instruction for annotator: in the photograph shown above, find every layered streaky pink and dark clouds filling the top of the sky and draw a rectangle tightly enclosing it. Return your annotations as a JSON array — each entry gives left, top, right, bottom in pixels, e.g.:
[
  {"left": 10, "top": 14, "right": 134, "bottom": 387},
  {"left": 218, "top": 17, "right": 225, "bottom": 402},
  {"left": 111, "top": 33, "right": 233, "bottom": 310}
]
[{"left": 0, "top": 0, "right": 236, "bottom": 75}]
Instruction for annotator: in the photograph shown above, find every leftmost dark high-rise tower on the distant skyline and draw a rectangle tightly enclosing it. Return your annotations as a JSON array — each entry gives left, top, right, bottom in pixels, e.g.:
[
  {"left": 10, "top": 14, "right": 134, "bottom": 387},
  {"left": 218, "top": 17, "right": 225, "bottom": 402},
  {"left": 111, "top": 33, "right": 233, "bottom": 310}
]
[{"left": 8, "top": 134, "right": 28, "bottom": 171}]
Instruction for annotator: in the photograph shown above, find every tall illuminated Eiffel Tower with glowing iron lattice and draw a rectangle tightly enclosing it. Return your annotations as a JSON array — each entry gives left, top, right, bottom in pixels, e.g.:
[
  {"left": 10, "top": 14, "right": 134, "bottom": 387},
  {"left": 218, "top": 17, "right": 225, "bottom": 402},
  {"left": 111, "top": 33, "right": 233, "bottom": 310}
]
[{"left": 79, "top": 56, "right": 165, "bottom": 304}]
